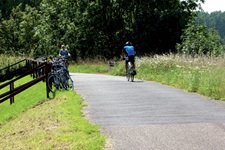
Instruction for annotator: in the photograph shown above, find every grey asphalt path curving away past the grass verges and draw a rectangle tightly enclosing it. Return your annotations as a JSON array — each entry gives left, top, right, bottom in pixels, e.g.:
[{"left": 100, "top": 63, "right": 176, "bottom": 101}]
[{"left": 72, "top": 73, "right": 225, "bottom": 150}]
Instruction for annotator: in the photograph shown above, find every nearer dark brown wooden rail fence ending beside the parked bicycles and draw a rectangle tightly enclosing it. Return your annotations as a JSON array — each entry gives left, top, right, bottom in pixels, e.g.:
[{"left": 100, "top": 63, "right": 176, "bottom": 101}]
[{"left": 0, "top": 59, "right": 51, "bottom": 104}]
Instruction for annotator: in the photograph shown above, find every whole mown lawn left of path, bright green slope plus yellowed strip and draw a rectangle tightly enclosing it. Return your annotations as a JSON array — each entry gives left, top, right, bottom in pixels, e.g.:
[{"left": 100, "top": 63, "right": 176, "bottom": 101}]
[{"left": 0, "top": 77, "right": 105, "bottom": 150}]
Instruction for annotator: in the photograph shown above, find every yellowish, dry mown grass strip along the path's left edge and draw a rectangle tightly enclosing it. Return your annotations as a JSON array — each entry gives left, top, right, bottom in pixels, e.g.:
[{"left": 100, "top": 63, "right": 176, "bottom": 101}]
[{"left": 0, "top": 91, "right": 105, "bottom": 150}]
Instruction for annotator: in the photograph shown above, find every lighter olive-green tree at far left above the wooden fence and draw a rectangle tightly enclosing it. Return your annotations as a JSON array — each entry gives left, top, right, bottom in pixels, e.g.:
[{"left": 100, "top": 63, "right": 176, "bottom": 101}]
[{"left": 0, "top": 5, "right": 40, "bottom": 55}]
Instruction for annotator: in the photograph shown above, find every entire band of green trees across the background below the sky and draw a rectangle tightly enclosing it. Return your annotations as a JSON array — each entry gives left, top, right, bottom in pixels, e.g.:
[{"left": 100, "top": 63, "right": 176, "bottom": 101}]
[{"left": 0, "top": 0, "right": 225, "bottom": 60}]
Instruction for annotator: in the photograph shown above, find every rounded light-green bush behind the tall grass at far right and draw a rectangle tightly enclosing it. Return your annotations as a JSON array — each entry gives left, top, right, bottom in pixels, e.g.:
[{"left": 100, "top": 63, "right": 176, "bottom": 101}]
[{"left": 177, "top": 21, "right": 224, "bottom": 56}]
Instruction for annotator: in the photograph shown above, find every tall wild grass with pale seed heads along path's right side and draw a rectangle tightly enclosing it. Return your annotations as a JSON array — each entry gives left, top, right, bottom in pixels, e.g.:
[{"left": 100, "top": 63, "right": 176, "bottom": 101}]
[{"left": 111, "top": 54, "right": 225, "bottom": 100}]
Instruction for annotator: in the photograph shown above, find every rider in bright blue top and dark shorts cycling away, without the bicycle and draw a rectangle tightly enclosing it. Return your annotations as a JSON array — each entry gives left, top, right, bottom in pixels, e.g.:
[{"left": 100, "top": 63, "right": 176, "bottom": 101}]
[{"left": 122, "top": 41, "right": 136, "bottom": 74}]
